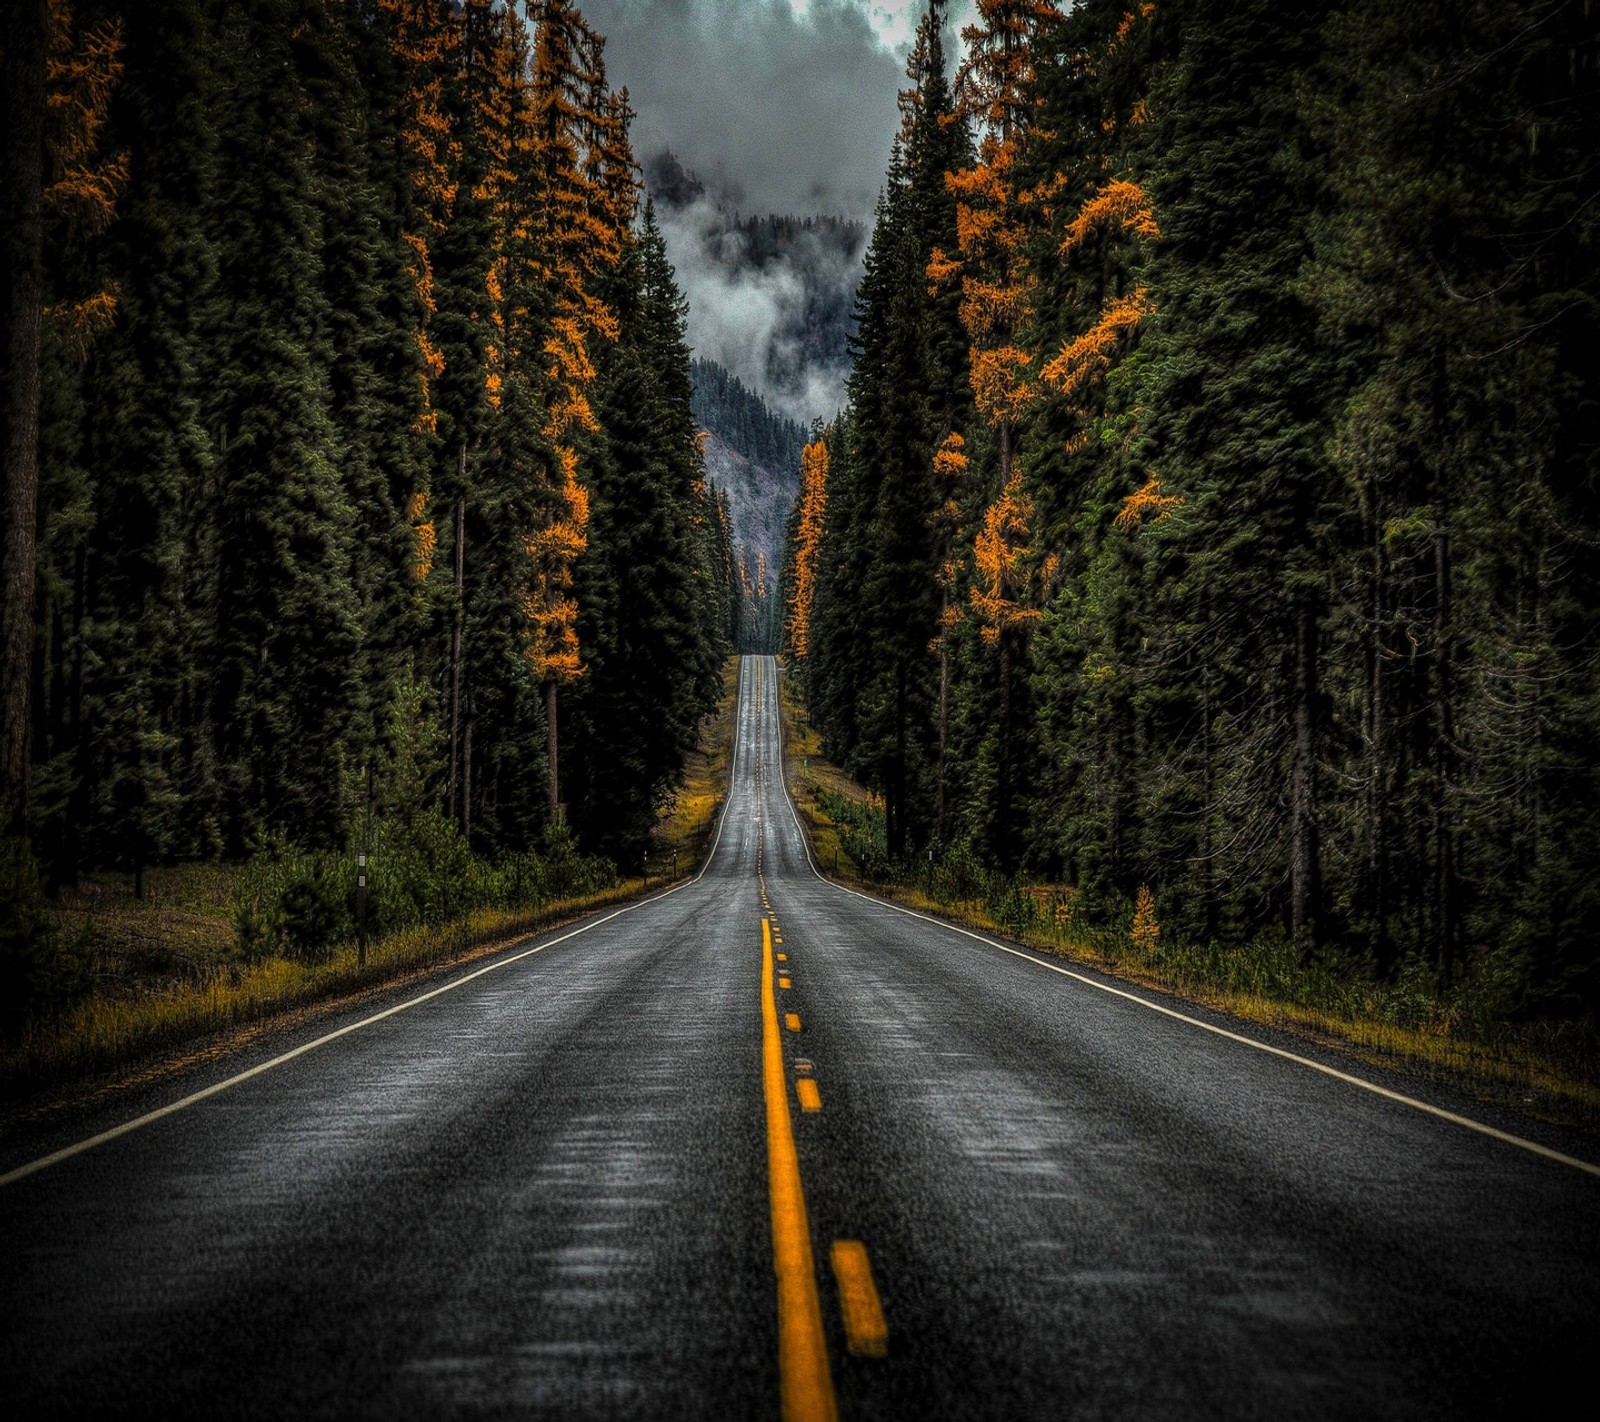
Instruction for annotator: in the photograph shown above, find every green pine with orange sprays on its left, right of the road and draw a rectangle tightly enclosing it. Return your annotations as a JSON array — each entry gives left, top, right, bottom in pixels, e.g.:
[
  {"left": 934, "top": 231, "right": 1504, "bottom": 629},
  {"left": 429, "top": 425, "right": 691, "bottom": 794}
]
[{"left": 1018, "top": 0, "right": 1176, "bottom": 917}]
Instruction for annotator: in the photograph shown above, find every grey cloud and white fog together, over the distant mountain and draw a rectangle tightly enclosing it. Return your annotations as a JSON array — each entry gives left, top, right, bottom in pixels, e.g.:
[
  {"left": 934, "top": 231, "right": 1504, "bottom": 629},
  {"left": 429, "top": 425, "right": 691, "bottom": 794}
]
[{"left": 582, "top": 0, "right": 922, "bottom": 425}]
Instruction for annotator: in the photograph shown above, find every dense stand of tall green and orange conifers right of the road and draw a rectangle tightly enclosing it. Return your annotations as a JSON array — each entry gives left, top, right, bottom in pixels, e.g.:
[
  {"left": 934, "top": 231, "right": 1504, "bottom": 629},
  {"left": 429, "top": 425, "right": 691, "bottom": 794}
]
[{"left": 786, "top": 0, "right": 1600, "bottom": 1013}]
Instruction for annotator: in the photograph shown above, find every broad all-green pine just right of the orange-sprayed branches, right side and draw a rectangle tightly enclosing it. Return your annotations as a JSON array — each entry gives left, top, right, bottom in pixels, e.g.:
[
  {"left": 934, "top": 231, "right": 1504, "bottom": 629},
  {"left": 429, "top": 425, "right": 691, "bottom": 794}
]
[{"left": 1133, "top": 0, "right": 1334, "bottom": 952}]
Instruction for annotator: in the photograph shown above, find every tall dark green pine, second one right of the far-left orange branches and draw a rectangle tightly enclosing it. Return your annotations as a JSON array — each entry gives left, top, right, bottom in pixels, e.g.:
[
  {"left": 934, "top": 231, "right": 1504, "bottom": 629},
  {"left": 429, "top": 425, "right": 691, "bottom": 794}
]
[{"left": 203, "top": 0, "right": 360, "bottom": 846}]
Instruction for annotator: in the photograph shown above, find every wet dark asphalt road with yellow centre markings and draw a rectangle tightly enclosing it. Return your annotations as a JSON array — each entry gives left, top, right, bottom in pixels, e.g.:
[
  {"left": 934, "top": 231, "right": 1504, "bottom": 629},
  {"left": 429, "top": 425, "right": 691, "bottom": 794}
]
[{"left": 0, "top": 659, "right": 1600, "bottom": 1419}]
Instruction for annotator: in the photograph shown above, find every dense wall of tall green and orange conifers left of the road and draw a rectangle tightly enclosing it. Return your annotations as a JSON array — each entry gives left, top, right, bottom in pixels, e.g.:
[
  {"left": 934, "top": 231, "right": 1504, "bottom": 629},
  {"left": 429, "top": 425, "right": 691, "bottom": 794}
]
[{"left": 0, "top": 0, "right": 739, "bottom": 880}]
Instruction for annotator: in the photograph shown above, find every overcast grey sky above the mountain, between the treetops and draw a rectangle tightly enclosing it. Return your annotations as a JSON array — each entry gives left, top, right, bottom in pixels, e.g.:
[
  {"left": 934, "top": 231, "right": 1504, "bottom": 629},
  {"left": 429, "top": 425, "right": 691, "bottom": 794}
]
[{"left": 579, "top": 0, "right": 968, "bottom": 221}]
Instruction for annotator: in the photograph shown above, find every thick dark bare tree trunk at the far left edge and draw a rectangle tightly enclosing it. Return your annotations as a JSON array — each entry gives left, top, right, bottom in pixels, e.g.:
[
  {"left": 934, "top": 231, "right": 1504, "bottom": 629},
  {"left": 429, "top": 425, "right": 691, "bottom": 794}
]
[{"left": 0, "top": 0, "right": 48, "bottom": 829}]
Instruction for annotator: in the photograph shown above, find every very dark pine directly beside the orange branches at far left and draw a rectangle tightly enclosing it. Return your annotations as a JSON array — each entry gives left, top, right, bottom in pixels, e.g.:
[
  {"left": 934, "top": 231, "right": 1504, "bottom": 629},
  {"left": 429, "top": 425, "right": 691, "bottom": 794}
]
[{"left": 70, "top": 3, "right": 216, "bottom": 883}]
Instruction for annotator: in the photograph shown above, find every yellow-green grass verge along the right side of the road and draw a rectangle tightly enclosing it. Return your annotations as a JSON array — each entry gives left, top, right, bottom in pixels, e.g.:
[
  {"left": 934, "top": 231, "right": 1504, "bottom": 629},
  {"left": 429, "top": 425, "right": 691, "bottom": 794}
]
[{"left": 782, "top": 686, "right": 1600, "bottom": 1134}]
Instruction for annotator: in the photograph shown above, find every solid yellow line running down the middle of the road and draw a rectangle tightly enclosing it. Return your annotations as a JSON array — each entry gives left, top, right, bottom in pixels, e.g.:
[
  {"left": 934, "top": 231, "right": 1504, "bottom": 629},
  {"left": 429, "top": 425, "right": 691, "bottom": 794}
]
[{"left": 762, "top": 918, "right": 838, "bottom": 1422}]
